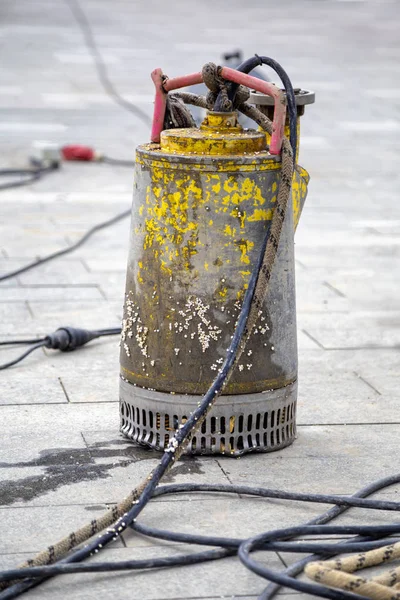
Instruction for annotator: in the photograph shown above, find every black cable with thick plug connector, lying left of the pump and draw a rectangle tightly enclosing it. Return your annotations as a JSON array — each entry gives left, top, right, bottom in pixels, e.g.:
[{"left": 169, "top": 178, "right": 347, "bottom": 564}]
[{"left": 0, "top": 327, "right": 121, "bottom": 371}]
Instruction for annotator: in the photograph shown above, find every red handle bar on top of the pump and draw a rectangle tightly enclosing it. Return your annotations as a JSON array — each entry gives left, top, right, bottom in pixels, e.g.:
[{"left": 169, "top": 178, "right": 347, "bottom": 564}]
[{"left": 151, "top": 67, "right": 286, "bottom": 154}]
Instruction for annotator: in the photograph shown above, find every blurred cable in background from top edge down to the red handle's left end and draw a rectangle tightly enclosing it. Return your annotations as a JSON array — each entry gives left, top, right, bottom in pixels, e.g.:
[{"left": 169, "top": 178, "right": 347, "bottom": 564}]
[{"left": 65, "top": 0, "right": 152, "bottom": 126}]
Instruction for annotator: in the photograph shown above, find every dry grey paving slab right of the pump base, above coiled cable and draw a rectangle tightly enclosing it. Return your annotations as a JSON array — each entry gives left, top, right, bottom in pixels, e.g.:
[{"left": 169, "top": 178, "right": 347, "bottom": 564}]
[{"left": 220, "top": 424, "right": 399, "bottom": 494}]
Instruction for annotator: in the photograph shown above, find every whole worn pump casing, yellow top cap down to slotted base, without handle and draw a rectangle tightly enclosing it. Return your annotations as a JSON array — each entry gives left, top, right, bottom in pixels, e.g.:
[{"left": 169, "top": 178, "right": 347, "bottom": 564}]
[{"left": 120, "top": 113, "right": 308, "bottom": 454}]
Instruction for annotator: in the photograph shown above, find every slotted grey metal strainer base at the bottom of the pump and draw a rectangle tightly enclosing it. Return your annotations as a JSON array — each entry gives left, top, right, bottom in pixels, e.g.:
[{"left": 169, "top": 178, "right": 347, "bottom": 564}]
[{"left": 120, "top": 379, "right": 297, "bottom": 455}]
